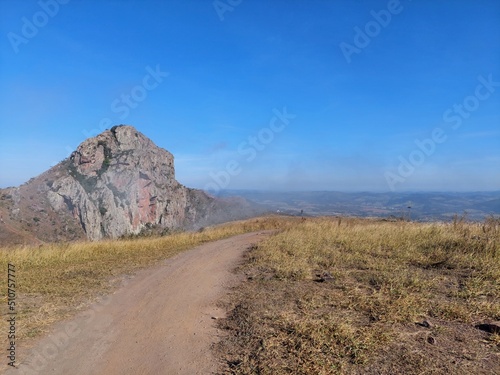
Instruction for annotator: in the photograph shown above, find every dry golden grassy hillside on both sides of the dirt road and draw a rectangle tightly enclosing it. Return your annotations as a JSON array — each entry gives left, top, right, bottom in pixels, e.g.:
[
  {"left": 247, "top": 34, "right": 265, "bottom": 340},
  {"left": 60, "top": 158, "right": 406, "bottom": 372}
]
[{"left": 0, "top": 217, "right": 500, "bottom": 374}]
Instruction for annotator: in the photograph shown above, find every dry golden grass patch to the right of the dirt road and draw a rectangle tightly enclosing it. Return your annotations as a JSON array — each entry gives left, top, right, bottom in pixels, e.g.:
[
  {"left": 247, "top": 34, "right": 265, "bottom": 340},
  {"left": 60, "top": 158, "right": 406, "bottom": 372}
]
[{"left": 219, "top": 218, "right": 500, "bottom": 374}]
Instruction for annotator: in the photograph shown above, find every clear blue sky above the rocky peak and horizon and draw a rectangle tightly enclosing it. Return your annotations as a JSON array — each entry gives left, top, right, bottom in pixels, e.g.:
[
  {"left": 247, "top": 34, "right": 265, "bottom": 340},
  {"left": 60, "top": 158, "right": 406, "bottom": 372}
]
[{"left": 0, "top": 0, "right": 500, "bottom": 191}]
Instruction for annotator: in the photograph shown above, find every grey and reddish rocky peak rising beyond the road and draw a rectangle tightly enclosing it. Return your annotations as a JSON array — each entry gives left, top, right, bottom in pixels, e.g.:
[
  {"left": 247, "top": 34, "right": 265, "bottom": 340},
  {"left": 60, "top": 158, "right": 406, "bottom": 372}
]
[{"left": 2, "top": 125, "right": 258, "bottom": 244}]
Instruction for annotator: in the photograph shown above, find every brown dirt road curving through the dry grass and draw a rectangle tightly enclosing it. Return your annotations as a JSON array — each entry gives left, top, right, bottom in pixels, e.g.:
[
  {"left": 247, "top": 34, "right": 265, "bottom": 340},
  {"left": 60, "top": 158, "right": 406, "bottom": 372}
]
[{"left": 7, "top": 232, "right": 269, "bottom": 375}]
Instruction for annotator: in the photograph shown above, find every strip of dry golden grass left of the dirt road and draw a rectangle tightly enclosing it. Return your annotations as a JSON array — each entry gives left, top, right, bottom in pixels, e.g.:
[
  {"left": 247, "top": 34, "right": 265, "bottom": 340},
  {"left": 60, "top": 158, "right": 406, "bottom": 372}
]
[{"left": 0, "top": 217, "right": 291, "bottom": 340}]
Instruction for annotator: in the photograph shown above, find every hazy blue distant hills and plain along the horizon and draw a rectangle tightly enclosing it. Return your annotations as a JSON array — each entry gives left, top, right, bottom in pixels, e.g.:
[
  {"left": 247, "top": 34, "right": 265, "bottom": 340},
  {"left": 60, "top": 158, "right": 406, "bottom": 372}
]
[{"left": 219, "top": 190, "right": 500, "bottom": 221}]
